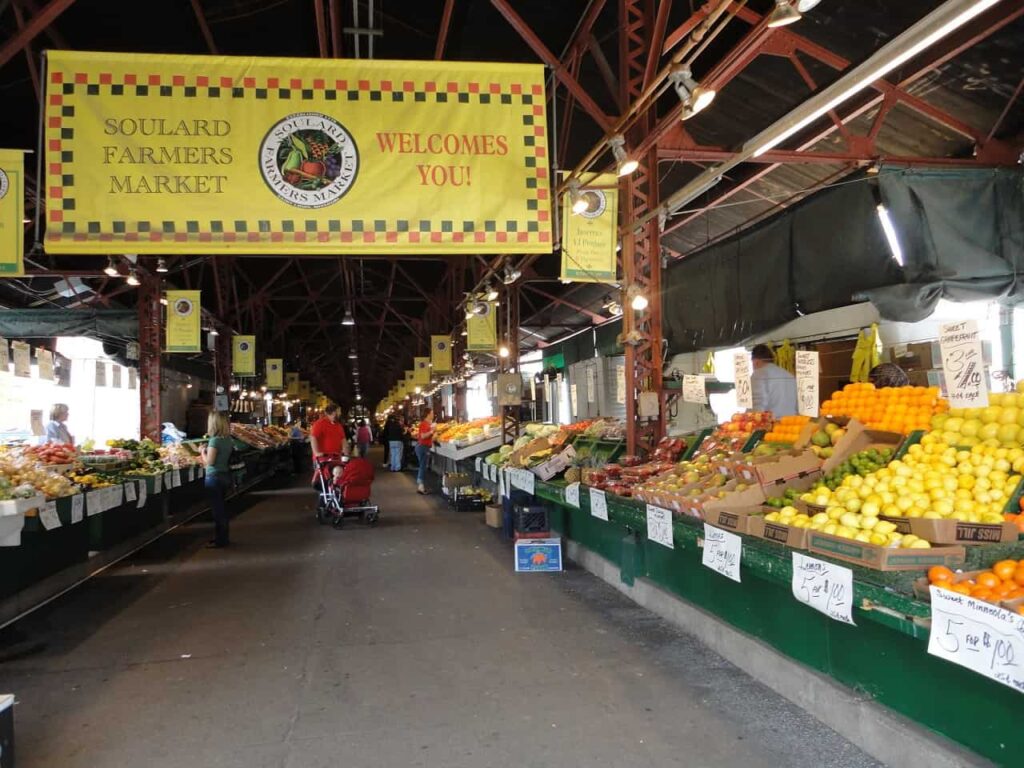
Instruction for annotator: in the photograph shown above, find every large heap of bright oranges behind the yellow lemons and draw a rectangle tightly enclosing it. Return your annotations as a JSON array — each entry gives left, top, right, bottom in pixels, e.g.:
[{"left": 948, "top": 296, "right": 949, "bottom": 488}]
[{"left": 821, "top": 384, "right": 949, "bottom": 434}]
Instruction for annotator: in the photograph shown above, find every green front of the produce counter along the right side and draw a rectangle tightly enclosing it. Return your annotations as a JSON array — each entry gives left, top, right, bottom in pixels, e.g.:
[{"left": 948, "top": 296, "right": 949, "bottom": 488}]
[{"left": 536, "top": 482, "right": 1024, "bottom": 765}]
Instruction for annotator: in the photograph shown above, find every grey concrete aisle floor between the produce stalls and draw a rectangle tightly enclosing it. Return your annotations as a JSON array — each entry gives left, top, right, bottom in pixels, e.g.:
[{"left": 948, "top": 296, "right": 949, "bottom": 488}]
[{"left": 0, "top": 456, "right": 878, "bottom": 768}]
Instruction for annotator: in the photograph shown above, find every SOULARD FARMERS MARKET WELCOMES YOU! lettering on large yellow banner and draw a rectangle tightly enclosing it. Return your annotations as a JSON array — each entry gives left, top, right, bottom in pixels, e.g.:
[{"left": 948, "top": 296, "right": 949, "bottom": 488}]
[{"left": 100, "top": 118, "right": 509, "bottom": 195}]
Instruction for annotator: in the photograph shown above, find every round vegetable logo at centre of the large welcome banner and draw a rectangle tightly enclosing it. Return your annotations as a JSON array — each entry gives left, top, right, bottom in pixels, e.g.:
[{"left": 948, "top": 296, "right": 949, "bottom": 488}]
[{"left": 259, "top": 112, "right": 359, "bottom": 208}]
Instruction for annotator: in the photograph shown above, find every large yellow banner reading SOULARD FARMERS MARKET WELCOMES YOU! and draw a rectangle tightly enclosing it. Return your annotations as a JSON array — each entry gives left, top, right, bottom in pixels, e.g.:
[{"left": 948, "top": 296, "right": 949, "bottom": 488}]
[{"left": 43, "top": 51, "right": 552, "bottom": 254}]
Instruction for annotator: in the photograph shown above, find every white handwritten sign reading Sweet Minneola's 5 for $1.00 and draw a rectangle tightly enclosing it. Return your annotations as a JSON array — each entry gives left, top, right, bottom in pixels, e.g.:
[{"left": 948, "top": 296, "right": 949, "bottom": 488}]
[{"left": 928, "top": 587, "right": 1024, "bottom": 692}]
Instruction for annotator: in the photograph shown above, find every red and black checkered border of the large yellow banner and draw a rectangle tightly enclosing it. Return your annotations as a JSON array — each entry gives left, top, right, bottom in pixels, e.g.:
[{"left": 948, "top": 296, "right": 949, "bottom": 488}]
[{"left": 46, "top": 72, "right": 551, "bottom": 245}]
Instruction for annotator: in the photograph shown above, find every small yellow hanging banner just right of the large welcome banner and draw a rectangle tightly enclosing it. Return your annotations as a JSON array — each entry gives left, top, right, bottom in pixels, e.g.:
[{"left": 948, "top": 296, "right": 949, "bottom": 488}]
[{"left": 562, "top": 173, "right": 618, "bottom": 283}]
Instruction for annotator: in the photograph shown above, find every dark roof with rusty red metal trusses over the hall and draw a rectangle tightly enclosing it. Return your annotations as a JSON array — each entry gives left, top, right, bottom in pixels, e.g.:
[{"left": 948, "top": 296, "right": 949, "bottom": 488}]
[{"left": 0, "top": 0, "right": 1024, "bottom": 438}]
